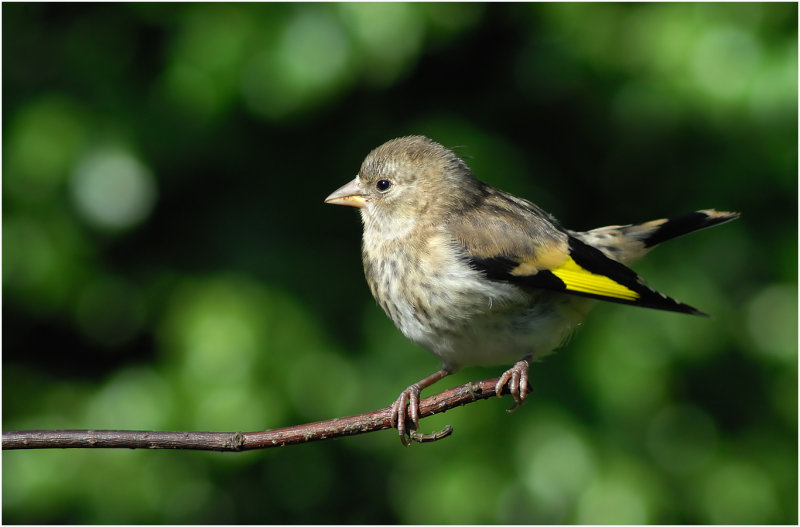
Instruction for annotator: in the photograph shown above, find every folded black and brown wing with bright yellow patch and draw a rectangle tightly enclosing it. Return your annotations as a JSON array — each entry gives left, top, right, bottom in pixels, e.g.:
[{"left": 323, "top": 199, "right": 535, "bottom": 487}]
[{"left": 447, "top": 191, "right": 704, "bottom": 315}]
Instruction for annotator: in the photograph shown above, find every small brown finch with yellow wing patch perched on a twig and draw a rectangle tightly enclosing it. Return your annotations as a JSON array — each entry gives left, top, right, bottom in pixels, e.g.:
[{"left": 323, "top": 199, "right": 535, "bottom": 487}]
[{"left": 325, "top": 135, "right": 739, "bottom": 444}]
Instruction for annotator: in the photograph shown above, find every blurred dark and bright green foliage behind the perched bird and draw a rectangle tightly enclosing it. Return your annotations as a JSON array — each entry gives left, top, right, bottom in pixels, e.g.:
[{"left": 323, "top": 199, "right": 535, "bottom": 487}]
[{"left": 2, "top": 3, "right": 798, "bottom": 524}]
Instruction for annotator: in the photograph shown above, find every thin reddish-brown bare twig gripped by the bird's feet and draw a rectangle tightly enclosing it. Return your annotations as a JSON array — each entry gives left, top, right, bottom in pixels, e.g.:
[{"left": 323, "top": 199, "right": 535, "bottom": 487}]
[{"left": 3, "top": 378, "right": 508, "bottom": 452}]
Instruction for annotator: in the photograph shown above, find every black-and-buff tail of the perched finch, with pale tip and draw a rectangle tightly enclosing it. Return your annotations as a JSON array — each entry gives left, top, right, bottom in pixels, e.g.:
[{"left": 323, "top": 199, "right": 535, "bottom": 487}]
[{"left": 574, "top": 209, "right": 739, "bottom": 264}]
